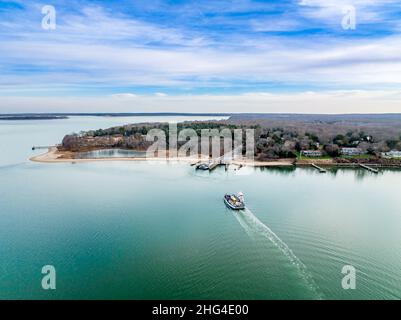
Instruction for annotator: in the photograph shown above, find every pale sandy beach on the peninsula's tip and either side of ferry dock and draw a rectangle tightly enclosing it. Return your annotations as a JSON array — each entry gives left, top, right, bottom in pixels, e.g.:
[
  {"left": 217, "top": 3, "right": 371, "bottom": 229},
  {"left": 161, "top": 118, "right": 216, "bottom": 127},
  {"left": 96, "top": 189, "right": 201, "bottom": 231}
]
[{"left": 29, "top": 147, "right": 293, "bottom": 167}]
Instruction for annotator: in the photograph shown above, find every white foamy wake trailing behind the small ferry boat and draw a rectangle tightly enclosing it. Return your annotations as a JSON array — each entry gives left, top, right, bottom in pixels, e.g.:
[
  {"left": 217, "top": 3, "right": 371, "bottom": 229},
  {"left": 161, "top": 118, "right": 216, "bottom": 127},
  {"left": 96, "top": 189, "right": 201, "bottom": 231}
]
[{"left": 234, "top": 208, "right": 323, "bottom": 299}]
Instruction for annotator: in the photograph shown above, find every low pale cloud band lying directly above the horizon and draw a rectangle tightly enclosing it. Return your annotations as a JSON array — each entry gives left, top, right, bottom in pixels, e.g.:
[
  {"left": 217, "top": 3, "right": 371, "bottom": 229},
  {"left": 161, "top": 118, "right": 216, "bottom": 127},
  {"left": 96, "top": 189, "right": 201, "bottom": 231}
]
[{"left": 0, "top": 90, "right": 401, "bottom": 113}]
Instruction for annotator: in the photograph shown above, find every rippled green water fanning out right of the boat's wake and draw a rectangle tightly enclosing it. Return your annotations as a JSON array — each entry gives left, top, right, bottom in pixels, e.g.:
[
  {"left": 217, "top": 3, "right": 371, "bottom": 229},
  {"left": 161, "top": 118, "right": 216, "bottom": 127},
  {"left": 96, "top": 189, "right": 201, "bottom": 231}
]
[{"left": 268, "top": 225, "right": 400, "bottom": 299}]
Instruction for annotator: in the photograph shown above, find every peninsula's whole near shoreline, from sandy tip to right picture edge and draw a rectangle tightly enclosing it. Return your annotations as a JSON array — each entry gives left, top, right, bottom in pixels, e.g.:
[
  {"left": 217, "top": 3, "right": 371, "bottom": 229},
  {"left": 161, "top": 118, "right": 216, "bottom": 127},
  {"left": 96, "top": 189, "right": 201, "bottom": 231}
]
[{"left": 29, "top": 147, "right": 401, "bottom": 168}]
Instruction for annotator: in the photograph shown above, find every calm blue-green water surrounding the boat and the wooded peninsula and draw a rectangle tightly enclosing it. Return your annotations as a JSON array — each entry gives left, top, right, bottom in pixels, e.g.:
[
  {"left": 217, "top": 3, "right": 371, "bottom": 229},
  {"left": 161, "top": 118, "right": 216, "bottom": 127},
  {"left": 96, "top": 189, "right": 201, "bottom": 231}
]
[{"left": 0, "top": 118, "right": 401, "bottom": 299}]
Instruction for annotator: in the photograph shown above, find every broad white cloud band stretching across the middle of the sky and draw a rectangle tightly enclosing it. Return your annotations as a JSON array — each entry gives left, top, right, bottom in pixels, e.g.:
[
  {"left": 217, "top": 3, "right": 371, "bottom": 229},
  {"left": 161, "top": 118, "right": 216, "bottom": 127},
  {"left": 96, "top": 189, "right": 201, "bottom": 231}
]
[{"left": 0, "top": 31, "right": 401, "bottom": 91}]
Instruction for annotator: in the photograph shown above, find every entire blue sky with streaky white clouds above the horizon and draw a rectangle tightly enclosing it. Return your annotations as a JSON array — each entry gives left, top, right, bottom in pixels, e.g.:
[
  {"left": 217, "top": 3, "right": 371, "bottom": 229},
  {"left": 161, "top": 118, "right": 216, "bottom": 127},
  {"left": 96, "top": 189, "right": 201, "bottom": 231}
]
[{"left": 0, "top": 0, "right": 401, "bottom": 113}]
